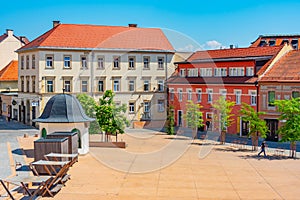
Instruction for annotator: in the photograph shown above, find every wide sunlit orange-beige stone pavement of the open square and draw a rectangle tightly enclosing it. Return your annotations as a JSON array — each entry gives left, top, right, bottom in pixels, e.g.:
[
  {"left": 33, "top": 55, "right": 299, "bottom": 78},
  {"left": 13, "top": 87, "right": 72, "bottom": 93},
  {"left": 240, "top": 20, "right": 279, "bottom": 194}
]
[{"left": 39, "top": 131, "right": 300, "bottom": 200}]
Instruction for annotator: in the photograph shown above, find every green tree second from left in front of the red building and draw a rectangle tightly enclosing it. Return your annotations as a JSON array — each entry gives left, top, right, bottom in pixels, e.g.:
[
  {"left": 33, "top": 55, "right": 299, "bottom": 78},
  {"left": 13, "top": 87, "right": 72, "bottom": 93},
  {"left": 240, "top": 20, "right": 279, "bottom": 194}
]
[{"left": 183, "top": 101, "right": 203, "bottom": 138}]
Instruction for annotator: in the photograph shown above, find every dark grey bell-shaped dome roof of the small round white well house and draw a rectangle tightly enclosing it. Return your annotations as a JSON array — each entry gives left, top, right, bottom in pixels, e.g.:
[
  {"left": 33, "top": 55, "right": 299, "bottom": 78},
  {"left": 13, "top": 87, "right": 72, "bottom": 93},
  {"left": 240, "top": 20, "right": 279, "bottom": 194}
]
[{"left": 33, "top": 94, "right": 95, "bottom": 123}]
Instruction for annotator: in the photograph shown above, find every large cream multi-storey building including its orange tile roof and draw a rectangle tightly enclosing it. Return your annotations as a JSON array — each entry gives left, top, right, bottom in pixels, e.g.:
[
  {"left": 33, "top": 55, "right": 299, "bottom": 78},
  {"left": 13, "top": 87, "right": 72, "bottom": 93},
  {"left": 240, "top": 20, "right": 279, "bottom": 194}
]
[{"left": 17, "top": 21, "right": 175, "bottom": 128}]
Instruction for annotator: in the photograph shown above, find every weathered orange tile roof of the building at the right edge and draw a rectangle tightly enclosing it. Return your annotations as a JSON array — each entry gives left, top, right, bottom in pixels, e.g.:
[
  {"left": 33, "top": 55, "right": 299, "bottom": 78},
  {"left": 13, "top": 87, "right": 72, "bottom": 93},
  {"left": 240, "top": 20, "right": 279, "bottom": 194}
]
[{"left": 260, "top": 50, "right": 300, "bottom": 82}]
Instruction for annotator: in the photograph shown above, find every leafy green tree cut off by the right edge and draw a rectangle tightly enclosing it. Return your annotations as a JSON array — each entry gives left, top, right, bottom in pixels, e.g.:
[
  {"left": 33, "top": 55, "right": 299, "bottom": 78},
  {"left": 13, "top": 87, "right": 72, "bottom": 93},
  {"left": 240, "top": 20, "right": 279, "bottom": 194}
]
[{"left": 274, "top": 97, "right": 300, "bottom": 157}]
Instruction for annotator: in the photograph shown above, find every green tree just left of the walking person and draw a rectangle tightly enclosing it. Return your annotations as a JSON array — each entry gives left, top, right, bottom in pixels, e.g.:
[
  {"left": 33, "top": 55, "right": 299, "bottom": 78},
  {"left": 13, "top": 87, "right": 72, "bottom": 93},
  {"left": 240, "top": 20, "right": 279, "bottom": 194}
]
[{"left": 240, "top": 103, "right": 269, "bottom": 151}]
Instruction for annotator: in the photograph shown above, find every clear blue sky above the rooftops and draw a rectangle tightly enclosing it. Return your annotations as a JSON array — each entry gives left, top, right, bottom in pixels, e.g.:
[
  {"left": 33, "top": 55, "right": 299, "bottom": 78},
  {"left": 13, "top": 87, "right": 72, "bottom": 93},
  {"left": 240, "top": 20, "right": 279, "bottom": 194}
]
[{"left": 0, "top": 0, "right": 300, "bottom": 49}]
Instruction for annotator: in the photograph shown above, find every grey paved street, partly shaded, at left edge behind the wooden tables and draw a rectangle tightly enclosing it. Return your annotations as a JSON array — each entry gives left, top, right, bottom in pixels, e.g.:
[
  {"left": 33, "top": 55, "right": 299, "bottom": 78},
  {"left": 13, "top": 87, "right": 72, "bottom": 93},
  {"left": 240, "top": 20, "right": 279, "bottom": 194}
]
[{"left": 0, "top": 117, "right": 38, "bottom": 178}]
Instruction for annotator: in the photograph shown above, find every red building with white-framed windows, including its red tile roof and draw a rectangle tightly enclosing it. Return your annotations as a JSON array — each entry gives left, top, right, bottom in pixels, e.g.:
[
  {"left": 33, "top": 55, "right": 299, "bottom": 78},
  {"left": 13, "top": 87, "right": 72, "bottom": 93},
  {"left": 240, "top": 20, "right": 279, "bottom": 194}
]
[{"left": 167, "top": 46, "right": 285, "bottom": 135}]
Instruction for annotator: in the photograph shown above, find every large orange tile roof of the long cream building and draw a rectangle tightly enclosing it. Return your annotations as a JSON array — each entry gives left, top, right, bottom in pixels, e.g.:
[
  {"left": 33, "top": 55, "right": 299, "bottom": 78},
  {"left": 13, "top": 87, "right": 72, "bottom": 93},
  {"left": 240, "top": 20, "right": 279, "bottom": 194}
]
[{"left": 20, "top": 24, "right": 174, "bottom": 51}]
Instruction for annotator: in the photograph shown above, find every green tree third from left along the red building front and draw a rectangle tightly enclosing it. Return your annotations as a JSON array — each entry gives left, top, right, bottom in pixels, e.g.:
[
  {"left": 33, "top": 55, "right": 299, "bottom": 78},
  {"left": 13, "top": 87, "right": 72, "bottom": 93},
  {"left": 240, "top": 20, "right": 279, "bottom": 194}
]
[{"left": 212, "top": 96, "right": 235, "bottom": 144}]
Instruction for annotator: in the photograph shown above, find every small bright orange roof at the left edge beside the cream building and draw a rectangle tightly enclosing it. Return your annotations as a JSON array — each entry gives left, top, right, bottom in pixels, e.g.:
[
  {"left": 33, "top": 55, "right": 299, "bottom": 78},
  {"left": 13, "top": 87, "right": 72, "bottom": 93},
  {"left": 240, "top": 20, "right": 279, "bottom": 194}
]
[{"left": 0, "top": 60, "right": 18, "bottom": 81}]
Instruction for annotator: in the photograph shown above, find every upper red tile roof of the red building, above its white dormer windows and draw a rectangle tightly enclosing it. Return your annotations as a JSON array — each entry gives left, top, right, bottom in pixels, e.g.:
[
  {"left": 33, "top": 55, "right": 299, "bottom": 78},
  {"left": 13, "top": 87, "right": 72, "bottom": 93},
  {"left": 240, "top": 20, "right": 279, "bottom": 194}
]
[{"left": 188, "top": 46, "right": 283, "bottom": 62}]
